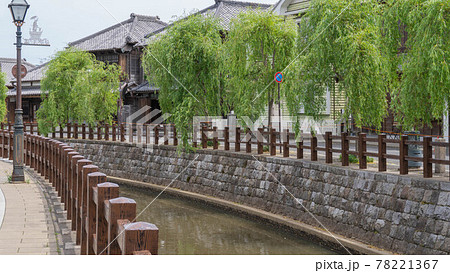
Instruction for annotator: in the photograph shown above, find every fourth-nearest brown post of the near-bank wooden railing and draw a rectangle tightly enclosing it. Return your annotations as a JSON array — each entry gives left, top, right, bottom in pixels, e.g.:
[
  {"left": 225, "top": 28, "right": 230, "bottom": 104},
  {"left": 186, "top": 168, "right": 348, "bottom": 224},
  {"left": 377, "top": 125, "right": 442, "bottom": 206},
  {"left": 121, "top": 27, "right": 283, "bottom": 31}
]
[{"left": 86, "top": 172, "right": 106, "bottom": 255}]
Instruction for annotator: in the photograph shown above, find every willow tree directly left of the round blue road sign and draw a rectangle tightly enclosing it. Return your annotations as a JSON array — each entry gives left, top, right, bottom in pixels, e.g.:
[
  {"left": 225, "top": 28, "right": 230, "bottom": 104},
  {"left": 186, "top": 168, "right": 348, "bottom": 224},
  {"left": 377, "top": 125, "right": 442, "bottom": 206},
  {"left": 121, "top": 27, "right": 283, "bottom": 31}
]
[{"left": 225, "top": 10, "right": 297, "bottom": 123}]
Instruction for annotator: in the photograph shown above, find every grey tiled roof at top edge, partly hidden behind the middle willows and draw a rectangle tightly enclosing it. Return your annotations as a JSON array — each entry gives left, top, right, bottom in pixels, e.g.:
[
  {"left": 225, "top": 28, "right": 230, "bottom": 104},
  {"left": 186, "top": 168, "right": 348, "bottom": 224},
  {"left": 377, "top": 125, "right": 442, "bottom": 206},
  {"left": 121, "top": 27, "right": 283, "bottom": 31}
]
[{"left": 146, "top": 0, "right": 272, "bottom": 42}]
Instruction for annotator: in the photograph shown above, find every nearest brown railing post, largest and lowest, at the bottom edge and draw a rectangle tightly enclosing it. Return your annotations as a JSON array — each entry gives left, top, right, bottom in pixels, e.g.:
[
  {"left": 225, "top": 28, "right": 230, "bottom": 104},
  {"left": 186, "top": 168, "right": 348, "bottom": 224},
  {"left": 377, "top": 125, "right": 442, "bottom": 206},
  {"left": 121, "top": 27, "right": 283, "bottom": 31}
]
[{"left": 117, "top": 220, "right": 159, "bottom": 255}]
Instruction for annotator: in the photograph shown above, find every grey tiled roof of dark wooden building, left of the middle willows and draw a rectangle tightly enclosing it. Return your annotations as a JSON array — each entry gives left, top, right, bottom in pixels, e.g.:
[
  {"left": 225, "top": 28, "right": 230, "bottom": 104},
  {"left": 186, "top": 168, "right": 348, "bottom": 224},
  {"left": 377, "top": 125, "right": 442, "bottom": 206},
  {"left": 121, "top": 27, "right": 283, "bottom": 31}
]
[{"left": 69, "top": 13, "right": 167, "bottom": 52}]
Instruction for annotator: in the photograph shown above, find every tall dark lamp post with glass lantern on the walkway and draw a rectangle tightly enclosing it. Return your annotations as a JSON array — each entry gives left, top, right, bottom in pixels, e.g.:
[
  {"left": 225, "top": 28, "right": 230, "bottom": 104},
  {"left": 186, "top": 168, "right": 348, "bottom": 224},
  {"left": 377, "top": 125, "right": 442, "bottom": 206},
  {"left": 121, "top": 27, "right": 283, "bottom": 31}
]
[{"left": 8, "top": 0, "right": 30, "bottom": 182}]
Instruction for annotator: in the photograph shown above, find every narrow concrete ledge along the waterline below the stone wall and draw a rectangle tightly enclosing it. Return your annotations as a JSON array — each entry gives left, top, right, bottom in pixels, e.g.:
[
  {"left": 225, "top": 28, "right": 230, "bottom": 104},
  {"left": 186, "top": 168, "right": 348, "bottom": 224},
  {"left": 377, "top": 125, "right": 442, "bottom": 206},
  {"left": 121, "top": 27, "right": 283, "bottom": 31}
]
[{"left": 108, "top": 176, "right": 395, "bottom": 255}]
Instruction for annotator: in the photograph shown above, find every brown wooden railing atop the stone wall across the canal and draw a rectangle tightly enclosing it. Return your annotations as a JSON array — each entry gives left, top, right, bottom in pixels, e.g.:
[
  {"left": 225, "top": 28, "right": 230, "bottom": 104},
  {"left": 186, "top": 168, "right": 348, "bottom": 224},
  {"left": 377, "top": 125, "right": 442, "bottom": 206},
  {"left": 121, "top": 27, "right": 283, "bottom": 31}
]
[{"left": 9, "top": 123, "right": 450, "bottom": 178}]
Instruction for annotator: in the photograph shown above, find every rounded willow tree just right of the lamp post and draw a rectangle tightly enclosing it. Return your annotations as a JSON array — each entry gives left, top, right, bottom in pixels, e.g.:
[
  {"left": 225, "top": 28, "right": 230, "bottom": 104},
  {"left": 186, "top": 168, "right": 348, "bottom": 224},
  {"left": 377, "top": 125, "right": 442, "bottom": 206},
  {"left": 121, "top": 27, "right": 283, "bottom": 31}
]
[{"left": 37, "top": 48, "right": 121, "bottom": 134}]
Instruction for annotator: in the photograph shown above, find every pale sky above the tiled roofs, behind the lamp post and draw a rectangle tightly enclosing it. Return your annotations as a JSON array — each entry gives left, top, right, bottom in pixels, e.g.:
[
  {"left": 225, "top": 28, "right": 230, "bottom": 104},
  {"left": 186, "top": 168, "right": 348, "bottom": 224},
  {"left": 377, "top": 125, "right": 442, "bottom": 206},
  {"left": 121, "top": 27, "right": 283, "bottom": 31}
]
[{"left": 0, "top": 0, "right": 277, "bottom": 65}]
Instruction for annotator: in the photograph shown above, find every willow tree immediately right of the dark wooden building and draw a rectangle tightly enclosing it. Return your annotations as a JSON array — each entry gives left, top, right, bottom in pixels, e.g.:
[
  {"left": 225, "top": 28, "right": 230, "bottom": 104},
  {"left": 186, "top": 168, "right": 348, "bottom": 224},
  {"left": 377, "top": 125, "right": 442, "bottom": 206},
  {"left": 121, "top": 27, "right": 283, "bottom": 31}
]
[{"left": 143, "top": 15, "right": 225, "bottom": 147}]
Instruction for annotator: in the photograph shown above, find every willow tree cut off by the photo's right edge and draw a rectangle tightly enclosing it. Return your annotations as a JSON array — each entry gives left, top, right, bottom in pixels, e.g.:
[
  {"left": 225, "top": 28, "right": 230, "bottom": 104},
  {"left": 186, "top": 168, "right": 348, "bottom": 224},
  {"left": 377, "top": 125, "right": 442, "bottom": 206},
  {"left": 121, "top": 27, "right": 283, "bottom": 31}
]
[{"left": 383, "top": 0, "right": 450, "bottom": 128}]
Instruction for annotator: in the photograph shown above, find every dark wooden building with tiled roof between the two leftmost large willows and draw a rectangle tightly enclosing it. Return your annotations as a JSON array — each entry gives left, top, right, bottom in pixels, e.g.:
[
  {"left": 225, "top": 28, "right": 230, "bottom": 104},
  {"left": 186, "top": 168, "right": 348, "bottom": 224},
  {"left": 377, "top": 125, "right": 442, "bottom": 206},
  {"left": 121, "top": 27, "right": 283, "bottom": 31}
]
[{"left": 69, "top": 13, "right": 167, "bottom": 121}]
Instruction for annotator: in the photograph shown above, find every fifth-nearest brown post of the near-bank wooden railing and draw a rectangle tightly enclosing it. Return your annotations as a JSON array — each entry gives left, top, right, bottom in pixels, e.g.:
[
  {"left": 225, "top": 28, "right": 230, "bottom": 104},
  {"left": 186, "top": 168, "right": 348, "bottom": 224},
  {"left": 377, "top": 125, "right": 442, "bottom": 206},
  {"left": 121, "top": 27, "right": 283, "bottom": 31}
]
[{"left": 79, "top": 165, "right": 98, "bottom": 255}]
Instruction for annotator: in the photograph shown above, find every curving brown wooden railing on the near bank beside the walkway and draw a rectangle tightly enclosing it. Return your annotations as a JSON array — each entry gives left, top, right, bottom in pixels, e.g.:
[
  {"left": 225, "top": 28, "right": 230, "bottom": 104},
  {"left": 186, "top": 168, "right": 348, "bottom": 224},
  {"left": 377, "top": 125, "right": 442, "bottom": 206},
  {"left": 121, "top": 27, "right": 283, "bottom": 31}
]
[{"left": 0, "top": 126, "right": 158, "bottom": 255}]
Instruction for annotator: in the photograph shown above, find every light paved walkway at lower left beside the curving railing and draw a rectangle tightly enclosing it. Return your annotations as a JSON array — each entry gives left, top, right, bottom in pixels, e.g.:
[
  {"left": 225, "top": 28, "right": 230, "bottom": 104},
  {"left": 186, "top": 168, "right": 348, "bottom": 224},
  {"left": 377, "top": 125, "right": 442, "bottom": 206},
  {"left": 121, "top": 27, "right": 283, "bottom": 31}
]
[{"left": 0, "top": 160, "right": 58, "bottom": 255}]
